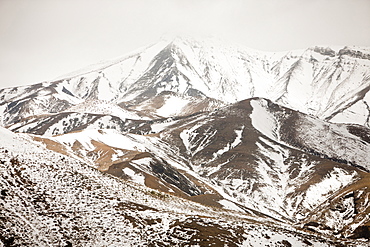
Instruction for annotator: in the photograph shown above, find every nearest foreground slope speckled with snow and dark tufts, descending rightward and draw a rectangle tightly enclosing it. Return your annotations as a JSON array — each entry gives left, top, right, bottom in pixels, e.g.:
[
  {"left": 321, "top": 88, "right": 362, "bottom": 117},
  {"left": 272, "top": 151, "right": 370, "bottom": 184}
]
[{"left": 0, "top": 128, "right": 354, "bottom": 246}]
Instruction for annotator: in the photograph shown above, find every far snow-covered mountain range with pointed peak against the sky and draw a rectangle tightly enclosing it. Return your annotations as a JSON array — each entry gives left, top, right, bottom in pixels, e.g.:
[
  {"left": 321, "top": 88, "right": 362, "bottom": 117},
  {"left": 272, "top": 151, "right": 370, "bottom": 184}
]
[{"left": 0, "top": 38, "right": 370, "bottom": 127}]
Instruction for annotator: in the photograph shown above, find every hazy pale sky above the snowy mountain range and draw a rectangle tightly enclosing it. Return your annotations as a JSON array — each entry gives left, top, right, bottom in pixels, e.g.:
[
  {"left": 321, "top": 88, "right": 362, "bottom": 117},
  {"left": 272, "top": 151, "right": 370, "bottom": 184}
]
[{"left": 0, "top": 0, "right": 370, "bottom": 88}]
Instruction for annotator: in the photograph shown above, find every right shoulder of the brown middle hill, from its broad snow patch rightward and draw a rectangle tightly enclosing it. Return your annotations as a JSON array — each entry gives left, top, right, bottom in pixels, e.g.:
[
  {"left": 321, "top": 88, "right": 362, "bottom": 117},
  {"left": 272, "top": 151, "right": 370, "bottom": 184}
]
[{"left": 251, "top": 99, "right": 370, "bottom": 170}]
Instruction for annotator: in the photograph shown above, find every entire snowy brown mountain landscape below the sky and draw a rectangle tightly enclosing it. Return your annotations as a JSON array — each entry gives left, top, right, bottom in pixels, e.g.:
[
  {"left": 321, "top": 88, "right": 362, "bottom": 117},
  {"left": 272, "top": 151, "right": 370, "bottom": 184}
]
[{"left": 0, "top": 38, "right": 370, "bottom": 246}]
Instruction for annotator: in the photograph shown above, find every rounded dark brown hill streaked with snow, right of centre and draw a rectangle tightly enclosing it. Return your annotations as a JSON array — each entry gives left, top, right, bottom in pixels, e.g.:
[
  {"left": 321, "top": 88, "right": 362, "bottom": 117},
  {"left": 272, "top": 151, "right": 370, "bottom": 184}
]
[{"left": 155, "top": 99, "right": 370, "bottom": 237}]
